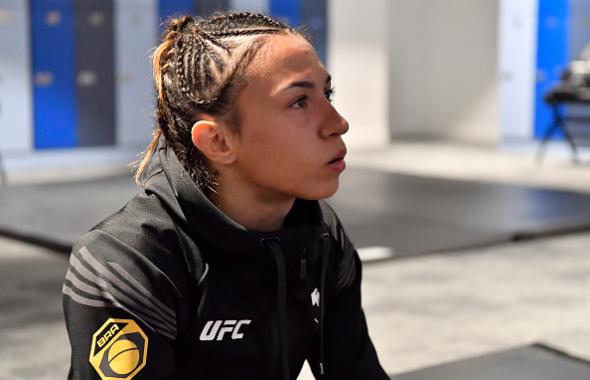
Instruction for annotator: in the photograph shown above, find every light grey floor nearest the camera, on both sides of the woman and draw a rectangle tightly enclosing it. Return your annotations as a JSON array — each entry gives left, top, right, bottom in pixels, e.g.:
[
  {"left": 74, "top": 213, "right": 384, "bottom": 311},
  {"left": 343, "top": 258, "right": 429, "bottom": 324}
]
[{"left": 0, "top": 234, "right": 590, "bottom": 380}]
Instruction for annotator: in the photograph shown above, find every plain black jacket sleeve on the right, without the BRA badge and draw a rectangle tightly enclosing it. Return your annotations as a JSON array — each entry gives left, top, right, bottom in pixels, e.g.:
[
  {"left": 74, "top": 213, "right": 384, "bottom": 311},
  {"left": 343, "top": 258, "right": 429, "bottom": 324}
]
[{"left": 312, "top": 200, "right": 389, "bottom": 380}]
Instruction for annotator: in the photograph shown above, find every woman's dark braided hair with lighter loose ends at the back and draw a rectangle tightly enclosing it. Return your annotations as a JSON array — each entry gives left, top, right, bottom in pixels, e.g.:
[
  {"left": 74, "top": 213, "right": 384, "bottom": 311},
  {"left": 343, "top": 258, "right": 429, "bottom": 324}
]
[{"left": 135, "top": 12, "right": 307, "bottom": 195}]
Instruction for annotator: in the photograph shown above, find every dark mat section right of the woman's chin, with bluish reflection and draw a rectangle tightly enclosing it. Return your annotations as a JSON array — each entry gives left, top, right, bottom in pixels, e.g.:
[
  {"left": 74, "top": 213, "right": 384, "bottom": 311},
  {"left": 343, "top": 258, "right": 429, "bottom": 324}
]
[{"left": 331, "top": 169, "right": 590, "bottom": 256}]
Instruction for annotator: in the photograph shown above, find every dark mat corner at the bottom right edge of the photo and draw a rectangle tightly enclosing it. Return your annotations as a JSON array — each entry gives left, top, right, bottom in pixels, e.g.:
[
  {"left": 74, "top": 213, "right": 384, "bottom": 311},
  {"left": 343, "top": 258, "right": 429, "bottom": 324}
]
[{"left": 392, "top": 345, "right": 590, "bottom": 380}]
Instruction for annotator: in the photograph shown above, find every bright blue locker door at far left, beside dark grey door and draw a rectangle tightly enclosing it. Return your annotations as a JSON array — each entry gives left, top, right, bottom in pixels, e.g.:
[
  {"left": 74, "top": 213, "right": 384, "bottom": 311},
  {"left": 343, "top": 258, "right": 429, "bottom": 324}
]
[{"left": 30, "top": 0, "right": 77, "bottom": 149}]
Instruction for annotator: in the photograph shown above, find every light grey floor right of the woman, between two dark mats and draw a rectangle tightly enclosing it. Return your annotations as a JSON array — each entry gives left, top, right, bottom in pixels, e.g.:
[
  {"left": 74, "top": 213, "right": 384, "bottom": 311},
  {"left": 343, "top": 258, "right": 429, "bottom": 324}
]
[{"left": 299, "top": 234, "right": 590, "bottom": 380}]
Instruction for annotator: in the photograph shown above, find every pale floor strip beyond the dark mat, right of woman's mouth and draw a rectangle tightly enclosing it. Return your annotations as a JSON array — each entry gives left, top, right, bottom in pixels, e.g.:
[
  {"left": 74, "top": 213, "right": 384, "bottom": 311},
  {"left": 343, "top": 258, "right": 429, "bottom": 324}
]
[{"left": 346, "top": 141, "right": 590, "bottom": 192}]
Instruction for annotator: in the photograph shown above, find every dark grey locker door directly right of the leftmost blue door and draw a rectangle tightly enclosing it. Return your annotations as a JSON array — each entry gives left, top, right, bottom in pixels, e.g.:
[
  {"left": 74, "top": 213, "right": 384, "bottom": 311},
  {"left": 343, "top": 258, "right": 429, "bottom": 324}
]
[{"left": 74, "top": 0, "right": 115, "bottom": 146}]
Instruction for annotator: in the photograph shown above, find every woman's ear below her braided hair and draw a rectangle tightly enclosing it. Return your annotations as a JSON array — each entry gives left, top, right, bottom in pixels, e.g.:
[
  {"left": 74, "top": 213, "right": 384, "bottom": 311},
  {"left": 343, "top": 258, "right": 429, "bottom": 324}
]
[{"left": 191, "top": 120, "right": 235, "bottom": 165}]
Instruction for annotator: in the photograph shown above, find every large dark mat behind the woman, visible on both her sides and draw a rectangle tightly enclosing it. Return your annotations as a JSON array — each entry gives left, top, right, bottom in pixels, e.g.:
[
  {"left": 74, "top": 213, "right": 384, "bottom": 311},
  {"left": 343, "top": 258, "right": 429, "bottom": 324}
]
[{"left": 0, "top": 169, "right": 590, "bottom": 256}]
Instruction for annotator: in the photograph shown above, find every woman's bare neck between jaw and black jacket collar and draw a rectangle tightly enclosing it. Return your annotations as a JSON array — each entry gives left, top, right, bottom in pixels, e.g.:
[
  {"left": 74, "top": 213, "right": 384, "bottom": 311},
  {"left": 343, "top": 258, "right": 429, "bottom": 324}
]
[{"left": 212, "top": 177, "right": 295, "bottom": 232}]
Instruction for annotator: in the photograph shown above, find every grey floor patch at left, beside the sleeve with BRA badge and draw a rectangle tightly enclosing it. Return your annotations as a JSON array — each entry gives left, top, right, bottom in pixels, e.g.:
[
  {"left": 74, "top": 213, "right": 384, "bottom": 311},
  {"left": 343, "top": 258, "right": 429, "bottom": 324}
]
[{"left": 0, "top": 239, "right": 70, "bottom": 380}]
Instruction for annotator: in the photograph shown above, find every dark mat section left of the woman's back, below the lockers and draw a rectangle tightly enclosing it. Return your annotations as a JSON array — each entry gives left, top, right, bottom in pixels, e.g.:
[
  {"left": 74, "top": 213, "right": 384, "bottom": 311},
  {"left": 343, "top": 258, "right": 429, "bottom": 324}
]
[{"left": 0, "top": 175, "right": 138, "bottom": 251}]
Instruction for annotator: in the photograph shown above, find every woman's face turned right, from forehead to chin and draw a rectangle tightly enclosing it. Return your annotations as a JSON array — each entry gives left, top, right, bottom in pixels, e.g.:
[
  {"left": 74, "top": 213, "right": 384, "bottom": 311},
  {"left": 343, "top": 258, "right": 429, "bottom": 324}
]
[{"left": 229, "top": 34, "right": 348, "bottom": 199}]
